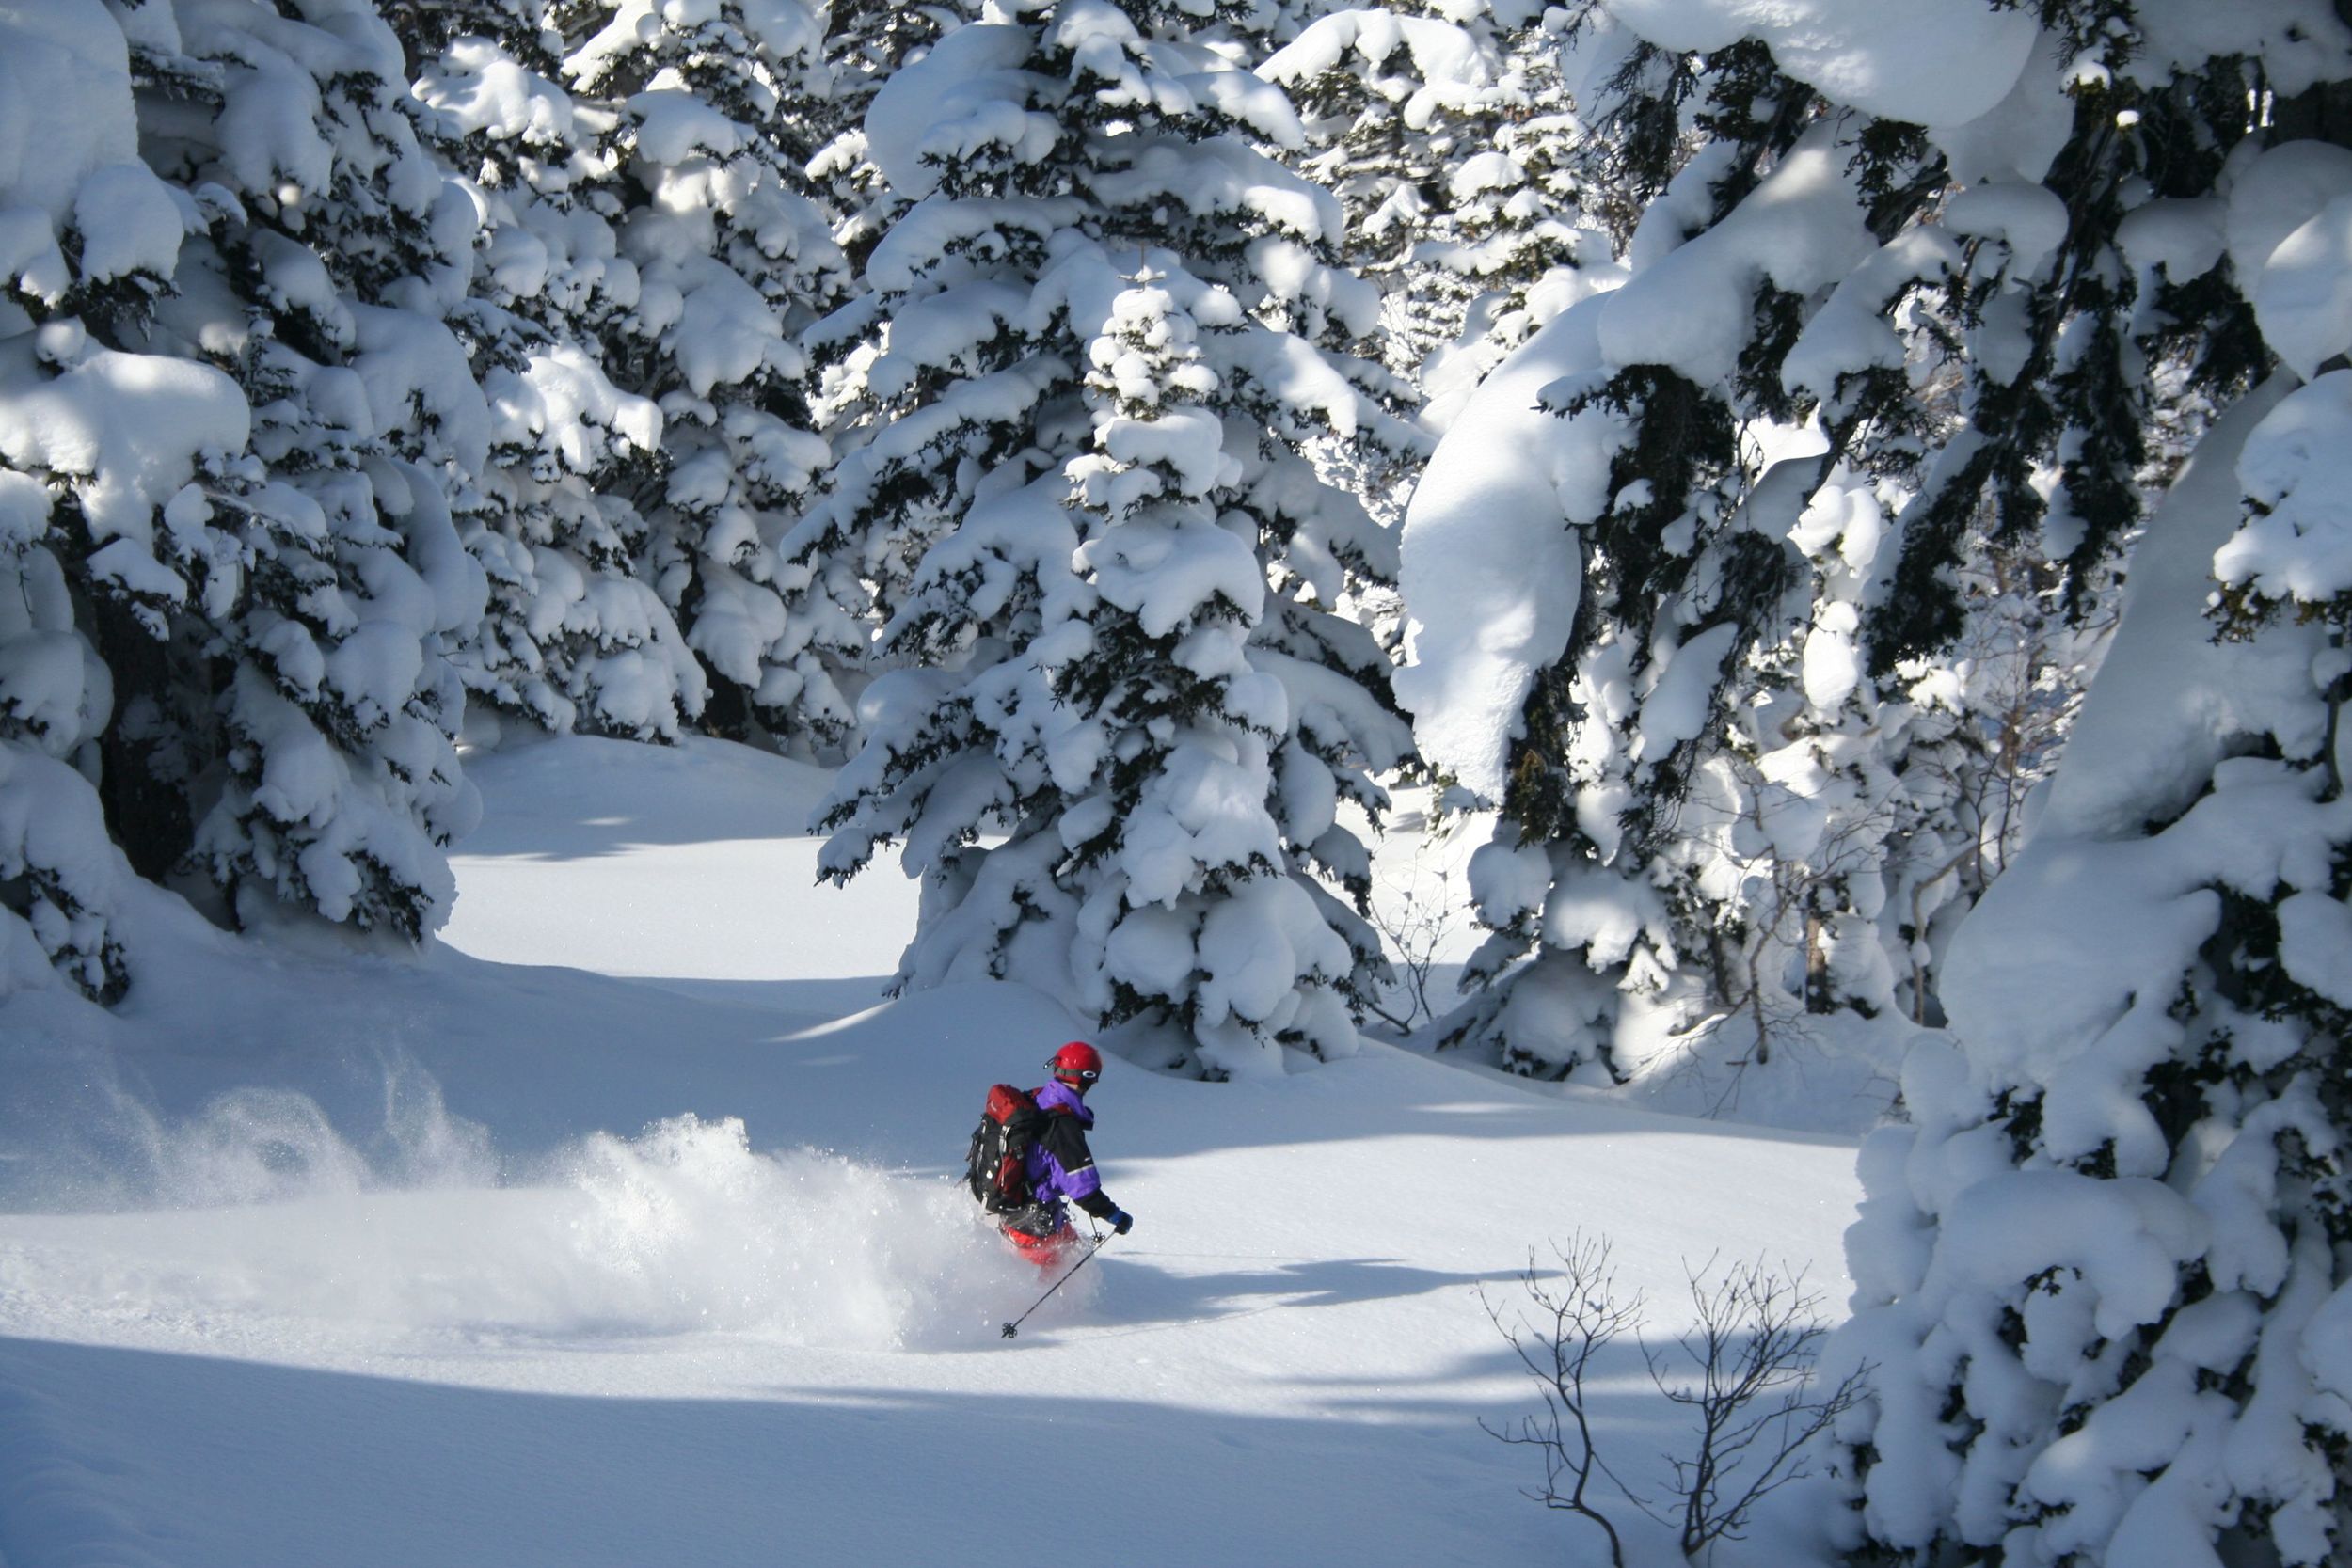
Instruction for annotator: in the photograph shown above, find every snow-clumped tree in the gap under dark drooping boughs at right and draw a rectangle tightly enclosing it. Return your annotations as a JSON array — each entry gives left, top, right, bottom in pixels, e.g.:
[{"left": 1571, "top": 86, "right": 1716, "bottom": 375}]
[{"left": 1651, "top": 467, "right": 2106, "bottom": 1115}]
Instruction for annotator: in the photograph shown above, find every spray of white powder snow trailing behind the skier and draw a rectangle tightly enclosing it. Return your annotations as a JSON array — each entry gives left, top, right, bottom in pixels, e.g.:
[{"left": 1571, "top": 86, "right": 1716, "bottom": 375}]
[{"left": 0, "top": 1091, "right": 1094, "bottom": 1350}]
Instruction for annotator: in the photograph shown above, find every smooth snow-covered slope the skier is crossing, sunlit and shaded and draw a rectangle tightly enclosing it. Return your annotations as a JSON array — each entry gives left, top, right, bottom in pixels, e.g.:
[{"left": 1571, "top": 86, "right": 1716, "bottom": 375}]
[{"left": 0, "top": 740, "right": 1853, "bottom": 1568}]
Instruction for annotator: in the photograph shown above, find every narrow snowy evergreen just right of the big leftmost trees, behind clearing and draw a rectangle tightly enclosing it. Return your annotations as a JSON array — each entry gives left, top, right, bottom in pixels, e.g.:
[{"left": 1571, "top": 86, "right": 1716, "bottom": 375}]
[{"left": 403, "top": 0, "right": 708, "bottom": 740}]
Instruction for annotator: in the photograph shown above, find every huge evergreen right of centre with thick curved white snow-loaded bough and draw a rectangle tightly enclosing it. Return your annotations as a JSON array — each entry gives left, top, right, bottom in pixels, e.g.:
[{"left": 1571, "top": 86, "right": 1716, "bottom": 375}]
[{"left": 1400, "top": 2, "right": 2247, "bottom": 1114}]
